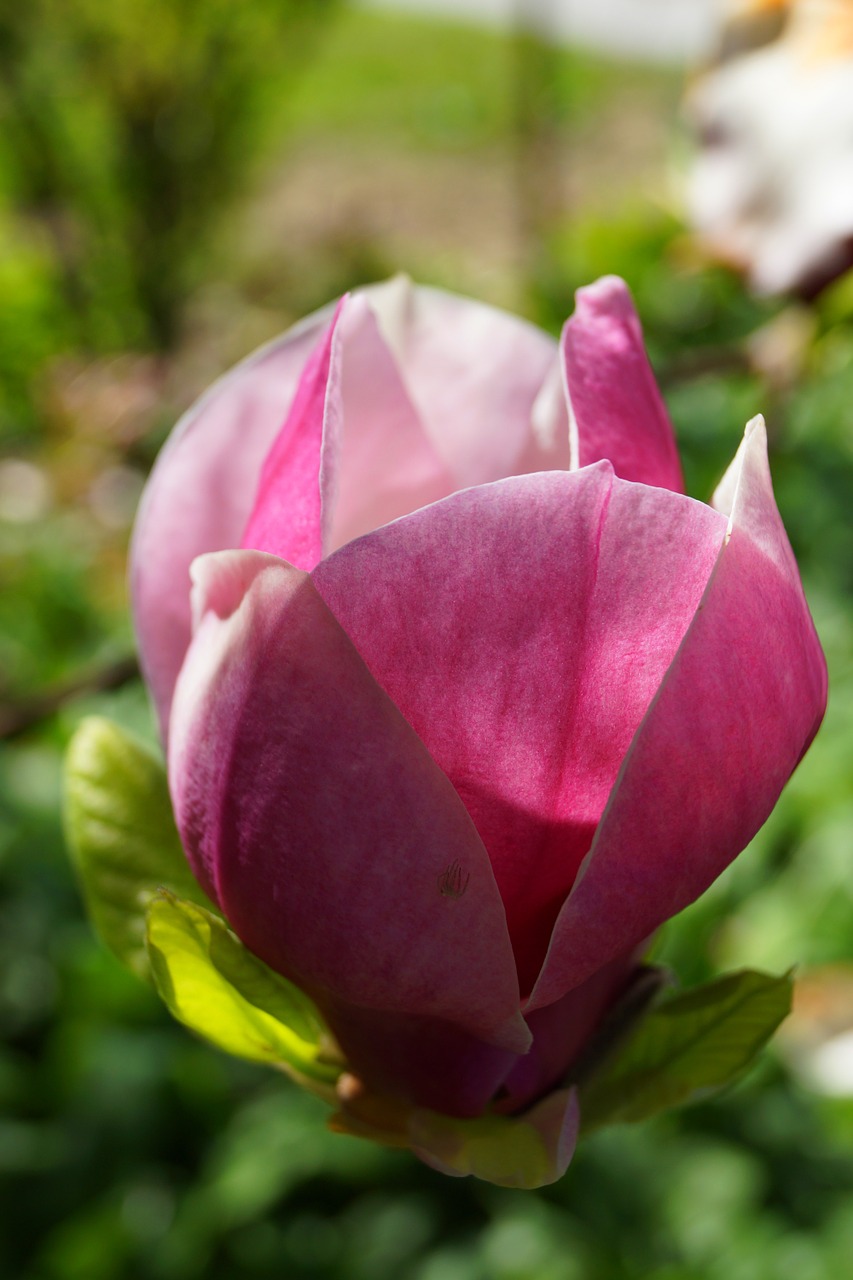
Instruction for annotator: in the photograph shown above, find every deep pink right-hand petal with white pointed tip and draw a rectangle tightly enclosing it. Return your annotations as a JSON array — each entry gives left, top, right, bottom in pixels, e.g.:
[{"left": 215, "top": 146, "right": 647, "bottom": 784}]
[{"left": 529, "top": 420, "right": 826, "bottom": 1009}]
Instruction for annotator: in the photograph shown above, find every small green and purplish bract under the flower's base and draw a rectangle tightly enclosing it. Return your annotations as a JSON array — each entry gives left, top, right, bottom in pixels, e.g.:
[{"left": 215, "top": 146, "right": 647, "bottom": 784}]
[{"left": 409, "top": 1089, "right": 580, "bottom": 1190}]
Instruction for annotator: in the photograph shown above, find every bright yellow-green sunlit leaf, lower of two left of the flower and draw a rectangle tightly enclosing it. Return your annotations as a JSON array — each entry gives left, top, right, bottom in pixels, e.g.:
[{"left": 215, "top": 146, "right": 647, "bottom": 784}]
[{"left": 147, "top": 892, "right": 341, "bottom": 1085}]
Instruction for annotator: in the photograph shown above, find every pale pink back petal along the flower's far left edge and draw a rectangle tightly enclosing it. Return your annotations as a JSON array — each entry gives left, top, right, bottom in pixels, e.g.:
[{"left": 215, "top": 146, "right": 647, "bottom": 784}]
[{"left": 131, "top": 308, "right": 332, "bottom": 736}]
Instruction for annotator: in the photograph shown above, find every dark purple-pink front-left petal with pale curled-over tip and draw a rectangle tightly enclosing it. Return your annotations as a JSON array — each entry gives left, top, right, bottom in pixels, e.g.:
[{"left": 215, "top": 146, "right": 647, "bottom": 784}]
[{"left": 169, "top": 552, "right": 529, "bottom": 1052}]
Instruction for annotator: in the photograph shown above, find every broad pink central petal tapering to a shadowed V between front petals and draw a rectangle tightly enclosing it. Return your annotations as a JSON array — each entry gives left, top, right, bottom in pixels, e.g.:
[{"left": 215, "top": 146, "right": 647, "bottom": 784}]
[{"left": 313, "top": 463, "right": 726, "bottom": 995}]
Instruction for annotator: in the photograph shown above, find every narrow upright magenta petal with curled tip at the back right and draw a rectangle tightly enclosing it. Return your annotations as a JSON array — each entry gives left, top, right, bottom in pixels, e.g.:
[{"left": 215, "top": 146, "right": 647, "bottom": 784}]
[{"left": 561, "top": 275, "right": 684, "bottom": 493}]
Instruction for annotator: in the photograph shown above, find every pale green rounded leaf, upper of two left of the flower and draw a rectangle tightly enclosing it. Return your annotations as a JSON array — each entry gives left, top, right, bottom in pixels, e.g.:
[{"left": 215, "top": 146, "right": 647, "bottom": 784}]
[{"left": 65, "top": 717, "right": 215, "bottom": 980}]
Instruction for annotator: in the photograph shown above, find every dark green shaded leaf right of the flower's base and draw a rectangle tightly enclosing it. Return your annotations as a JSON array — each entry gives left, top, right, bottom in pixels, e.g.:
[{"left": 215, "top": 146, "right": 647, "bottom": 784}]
[{"left": 580, "top": 970, "right": 793, "bottom": 1132}]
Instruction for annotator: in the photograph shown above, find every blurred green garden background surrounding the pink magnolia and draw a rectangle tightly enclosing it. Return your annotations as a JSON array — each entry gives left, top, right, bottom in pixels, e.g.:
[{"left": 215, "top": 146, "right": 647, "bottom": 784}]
[{"left": 0, "top": 0, "right": 853, "bottom": 1280}]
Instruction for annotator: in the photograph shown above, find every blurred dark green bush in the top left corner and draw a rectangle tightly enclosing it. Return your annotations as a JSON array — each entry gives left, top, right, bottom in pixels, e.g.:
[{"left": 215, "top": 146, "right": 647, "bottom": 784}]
[{"left": 0, "top": 0, "right": 334, "bottom": 349}]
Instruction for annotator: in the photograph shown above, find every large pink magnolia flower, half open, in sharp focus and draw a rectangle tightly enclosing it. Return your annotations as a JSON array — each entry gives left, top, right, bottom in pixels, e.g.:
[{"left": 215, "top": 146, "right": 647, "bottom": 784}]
[{"left": 132, "top": 278, "right": 826, "bottom": 1176}]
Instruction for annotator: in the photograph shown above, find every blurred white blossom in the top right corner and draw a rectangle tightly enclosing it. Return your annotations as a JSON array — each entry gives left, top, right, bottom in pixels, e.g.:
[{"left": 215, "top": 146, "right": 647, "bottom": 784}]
[{"left": 686, "top": 0, "right": 853, "bottom": 293}]
